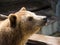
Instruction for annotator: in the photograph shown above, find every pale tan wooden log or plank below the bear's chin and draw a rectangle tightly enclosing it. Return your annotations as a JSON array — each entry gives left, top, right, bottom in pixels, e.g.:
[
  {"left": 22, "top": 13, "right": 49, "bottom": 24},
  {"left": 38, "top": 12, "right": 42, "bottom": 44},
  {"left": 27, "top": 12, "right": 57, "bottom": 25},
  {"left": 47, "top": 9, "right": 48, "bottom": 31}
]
[{"left": 29, "top": 34, "right": 60, "bottom": 45}]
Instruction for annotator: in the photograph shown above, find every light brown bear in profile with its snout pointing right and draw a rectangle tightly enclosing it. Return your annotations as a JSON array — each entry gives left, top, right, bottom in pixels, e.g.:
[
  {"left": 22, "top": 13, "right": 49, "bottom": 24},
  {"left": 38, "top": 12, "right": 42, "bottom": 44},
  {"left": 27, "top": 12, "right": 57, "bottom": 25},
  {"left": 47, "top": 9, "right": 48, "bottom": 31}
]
[{"left": 0, "top": 7, "right": 47, "bottom": 45}]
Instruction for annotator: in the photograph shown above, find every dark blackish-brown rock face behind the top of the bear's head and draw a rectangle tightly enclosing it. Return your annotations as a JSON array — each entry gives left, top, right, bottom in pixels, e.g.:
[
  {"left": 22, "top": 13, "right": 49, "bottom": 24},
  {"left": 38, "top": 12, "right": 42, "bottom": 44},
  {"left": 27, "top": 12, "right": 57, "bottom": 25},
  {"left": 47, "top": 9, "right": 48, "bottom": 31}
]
[{"left": 0, "top": 0, "right": 50, "bottom": 15}]
